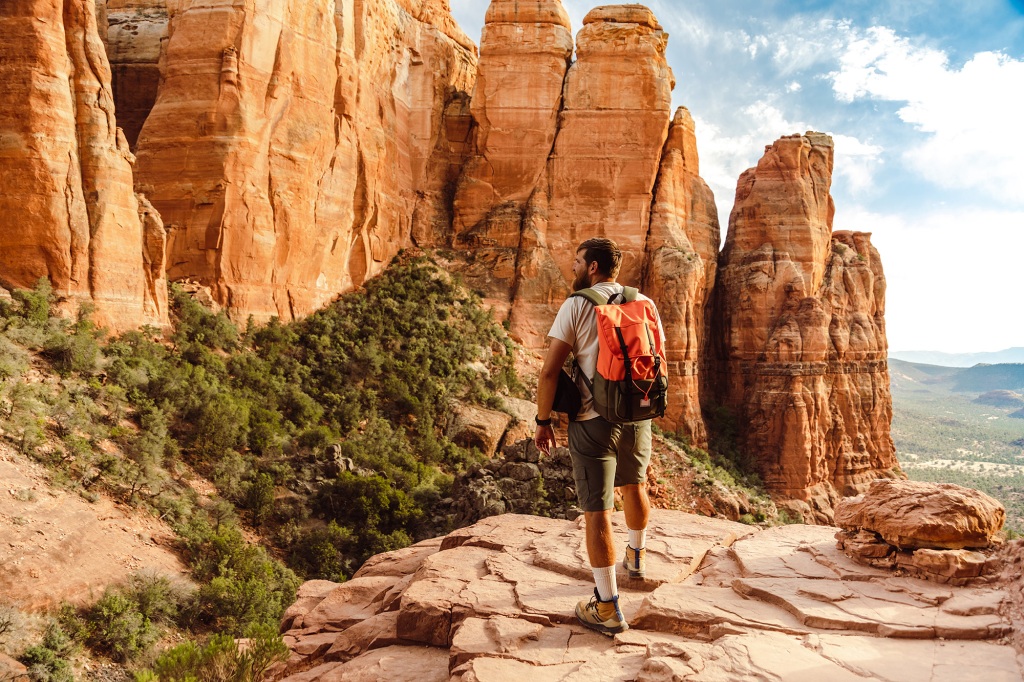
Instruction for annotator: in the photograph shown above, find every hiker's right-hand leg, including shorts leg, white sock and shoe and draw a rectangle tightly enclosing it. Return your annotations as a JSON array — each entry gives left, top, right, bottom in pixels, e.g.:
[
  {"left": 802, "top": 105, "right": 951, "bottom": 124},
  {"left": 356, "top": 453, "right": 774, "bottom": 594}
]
[{"left": 615, "top": 421, "right": 651, "bottom": 578}]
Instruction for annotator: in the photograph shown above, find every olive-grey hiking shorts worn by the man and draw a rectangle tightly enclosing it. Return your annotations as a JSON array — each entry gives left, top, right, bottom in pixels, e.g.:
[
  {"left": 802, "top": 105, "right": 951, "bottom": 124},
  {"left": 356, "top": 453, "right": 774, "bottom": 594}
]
[{"left": 569, "top": 417, "right": 651, "bottom": 511}]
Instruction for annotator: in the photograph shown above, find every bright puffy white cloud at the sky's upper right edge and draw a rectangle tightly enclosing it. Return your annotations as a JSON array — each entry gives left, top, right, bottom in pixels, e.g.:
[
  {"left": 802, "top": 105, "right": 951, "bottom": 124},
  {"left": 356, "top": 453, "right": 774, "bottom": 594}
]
[{"left": 829, "top": 27, "right": 1024, "bottom": 206}]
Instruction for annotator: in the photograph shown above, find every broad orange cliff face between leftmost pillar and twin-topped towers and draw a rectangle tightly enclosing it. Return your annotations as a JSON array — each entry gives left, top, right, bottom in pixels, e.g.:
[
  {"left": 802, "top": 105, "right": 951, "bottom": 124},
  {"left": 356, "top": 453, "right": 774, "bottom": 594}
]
[{"left": 131, "top": 0, "right": 475, "bottom": 319}]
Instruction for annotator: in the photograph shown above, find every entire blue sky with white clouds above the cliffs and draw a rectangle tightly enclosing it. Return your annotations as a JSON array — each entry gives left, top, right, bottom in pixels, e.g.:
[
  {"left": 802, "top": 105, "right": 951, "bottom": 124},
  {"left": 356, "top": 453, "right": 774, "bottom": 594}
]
[{"left": 451, "top": 0, "right": 1024, "bottom": 352}]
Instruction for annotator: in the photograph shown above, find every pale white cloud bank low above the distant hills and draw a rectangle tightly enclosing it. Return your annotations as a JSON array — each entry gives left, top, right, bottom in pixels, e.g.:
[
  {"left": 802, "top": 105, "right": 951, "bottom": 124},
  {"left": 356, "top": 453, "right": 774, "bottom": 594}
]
[{"left": 836, "top": 207, "right": 1024, "bottom": 352}]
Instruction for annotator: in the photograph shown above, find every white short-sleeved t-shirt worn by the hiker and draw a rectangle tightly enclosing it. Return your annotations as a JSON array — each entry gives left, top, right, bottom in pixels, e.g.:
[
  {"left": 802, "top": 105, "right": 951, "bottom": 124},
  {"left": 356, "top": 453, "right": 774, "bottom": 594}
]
[{"left": 548, "top": 282, "right": 665, "bottom": 422}]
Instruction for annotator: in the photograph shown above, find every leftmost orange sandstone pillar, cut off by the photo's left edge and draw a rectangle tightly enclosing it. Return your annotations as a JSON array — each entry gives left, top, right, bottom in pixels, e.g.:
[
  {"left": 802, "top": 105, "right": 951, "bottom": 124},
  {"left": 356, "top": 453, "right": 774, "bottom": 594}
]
[{"left": 0, "top": 0, "right": 167, "bottom": 330}]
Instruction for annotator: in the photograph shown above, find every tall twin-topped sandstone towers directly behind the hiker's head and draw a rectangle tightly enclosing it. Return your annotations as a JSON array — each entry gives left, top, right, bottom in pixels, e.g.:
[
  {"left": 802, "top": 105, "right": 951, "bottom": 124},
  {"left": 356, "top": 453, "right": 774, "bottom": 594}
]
[{"left": 444, "top": 0, "right": 719, "bottom": 444}]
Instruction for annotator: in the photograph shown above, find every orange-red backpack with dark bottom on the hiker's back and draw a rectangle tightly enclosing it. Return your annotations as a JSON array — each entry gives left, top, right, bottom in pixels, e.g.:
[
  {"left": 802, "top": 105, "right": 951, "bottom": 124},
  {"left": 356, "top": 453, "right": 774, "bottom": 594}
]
[{"left": 572, "top": 287, "right": 669, "bottom": 424}]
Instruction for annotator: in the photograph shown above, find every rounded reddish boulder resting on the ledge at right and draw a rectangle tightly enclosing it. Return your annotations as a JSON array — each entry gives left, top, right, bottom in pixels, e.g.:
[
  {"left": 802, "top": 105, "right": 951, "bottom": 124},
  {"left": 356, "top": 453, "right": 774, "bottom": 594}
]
[{"left": 836, "top": 480, "right": 1006, "bottom": 549}]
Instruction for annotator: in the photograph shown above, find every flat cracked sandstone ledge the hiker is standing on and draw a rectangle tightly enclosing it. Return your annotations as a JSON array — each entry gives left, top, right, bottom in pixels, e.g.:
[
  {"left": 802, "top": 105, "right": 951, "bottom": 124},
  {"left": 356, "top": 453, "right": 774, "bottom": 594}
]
[{"left": 274, "top": 511, "right": 1022, "bottom": 682}]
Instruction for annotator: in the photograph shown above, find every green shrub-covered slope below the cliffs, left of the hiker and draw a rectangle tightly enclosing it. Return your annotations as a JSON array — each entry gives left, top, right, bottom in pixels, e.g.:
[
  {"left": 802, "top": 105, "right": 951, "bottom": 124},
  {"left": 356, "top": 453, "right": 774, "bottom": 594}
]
[{"left": 0, "top": 258, "right": 522, "bottom": 680}]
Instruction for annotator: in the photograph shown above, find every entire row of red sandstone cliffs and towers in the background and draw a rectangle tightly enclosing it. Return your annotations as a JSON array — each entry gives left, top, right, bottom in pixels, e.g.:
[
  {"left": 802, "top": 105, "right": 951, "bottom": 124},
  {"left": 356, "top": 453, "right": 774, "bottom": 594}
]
[{"left": 0, "top": 0, "right": 895, "bottom": 520}]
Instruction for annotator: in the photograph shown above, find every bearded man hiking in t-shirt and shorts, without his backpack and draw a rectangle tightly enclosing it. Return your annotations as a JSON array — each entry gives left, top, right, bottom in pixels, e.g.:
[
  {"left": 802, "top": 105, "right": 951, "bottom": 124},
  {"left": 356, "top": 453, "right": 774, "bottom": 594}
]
[{"left": 534, "top": 239, "right": 664, "bottom": 635}]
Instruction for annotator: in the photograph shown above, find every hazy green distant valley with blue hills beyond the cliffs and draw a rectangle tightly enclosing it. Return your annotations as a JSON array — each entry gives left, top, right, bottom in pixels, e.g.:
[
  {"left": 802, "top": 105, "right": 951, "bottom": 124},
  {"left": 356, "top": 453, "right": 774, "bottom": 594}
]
[{"left": 889, "top": 357, "right": 1024, "bottom": 532}]
